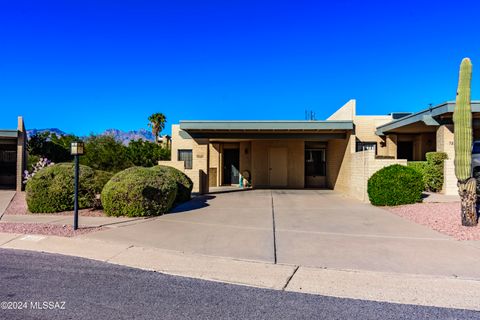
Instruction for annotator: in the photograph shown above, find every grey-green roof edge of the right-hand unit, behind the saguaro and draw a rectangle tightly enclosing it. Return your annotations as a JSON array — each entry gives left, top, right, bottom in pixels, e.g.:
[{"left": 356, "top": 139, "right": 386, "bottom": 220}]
[{"left": 376, "top": 101, "right": 480, "bottom": 135}]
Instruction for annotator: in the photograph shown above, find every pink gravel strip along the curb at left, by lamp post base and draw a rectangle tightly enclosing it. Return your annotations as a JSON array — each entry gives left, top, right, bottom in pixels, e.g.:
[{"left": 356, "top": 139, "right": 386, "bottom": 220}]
[{"left": 0, "top": 222, "right": 106, "bottom": 237}]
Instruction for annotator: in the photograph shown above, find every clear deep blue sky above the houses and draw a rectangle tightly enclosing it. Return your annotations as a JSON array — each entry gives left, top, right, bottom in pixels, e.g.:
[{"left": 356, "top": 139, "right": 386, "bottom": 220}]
[{"left": 0, "top": 0, "right": 480, "bottom": 135}]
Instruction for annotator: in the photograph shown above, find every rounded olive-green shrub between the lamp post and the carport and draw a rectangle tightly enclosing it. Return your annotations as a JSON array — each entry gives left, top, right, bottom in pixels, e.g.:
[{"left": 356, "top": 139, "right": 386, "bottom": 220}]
[{"left": 101, "top": 167, "right": 177, "bottom": 217}]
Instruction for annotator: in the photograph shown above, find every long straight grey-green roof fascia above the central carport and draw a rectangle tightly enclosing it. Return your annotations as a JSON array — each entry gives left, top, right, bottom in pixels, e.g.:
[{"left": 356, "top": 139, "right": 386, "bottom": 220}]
[{"left": 180, "top": 120, "right": 353, "bottom": 132}]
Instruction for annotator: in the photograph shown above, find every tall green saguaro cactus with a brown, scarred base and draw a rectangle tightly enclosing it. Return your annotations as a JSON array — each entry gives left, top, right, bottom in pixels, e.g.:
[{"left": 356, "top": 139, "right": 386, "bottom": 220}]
[{"left": 453, "top": 58, "right": 478, "bottom": 226}]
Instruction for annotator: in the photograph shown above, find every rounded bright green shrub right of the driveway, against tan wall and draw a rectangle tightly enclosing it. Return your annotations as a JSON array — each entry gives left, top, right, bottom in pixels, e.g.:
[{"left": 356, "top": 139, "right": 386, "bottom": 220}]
[{"left": 368, "top": 164, "right": 424, "bottom": 206}]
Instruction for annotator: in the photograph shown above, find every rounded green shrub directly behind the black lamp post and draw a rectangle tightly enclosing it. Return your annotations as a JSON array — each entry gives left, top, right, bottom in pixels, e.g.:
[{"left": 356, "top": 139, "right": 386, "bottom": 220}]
[{"left": 26, "top": 163, "right": 95, "bottom": 213}]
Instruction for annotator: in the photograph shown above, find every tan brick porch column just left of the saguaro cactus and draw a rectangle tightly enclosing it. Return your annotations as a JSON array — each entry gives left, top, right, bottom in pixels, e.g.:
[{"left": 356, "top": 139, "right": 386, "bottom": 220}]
[{"left": 437, "top": 124, "right": 458, "bottom": 195}]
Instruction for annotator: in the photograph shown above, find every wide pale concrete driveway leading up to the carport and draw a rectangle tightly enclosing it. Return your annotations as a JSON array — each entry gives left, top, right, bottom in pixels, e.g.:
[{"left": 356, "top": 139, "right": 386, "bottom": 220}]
[{"left": 82, "top": 190, "right": 480, "bottom": 279}]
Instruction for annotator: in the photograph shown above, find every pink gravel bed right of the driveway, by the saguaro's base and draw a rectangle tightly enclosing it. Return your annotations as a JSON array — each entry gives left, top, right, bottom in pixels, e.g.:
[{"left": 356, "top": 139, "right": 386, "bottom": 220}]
[{"left": 387, "top": 202, "right": 480, "bottom": 240}]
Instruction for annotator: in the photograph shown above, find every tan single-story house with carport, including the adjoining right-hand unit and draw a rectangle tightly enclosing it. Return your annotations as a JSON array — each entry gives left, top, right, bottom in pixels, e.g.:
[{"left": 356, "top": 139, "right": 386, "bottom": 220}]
[{"left": 160, "top": 100, "right": 480, "bottom": 201}]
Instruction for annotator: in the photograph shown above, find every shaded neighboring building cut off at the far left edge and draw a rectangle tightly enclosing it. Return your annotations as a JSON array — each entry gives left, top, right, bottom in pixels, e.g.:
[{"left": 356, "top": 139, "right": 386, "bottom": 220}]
[{"left": 0, "top": 117, "right": 27, "bottom": 191}]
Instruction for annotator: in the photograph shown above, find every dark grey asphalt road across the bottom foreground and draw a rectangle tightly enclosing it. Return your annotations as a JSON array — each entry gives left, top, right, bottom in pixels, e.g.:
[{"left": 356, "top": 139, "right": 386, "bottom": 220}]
[{"left": 0, "top": 249, "right": 480, "bottom": 320}]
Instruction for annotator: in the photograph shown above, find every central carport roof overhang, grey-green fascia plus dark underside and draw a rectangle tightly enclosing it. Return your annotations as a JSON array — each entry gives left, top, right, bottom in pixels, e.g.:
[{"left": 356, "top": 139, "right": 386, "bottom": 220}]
[{"left": 180, "top": 121, "right": 353, "bottom": 140}]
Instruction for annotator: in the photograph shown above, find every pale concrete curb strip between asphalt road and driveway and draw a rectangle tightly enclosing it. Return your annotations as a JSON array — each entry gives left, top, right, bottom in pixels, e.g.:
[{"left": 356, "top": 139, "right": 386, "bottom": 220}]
[{"left": 0, "top": 233, "right": 480, "bottom": 311}]
